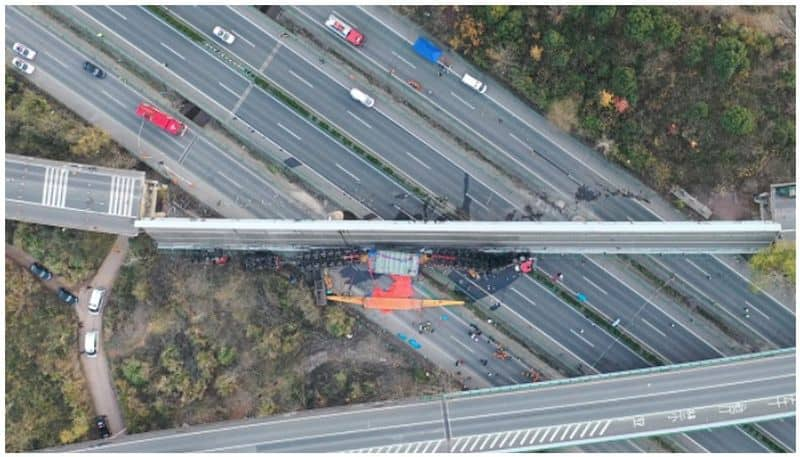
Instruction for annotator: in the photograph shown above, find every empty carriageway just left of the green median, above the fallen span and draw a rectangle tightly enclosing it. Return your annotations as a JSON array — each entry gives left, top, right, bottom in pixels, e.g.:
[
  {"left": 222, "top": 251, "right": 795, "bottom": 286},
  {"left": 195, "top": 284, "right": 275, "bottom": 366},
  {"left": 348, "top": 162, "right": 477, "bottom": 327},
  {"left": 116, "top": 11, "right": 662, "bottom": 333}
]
[{"left": 79, "top": 6, "right": 432, "bottom": 219}]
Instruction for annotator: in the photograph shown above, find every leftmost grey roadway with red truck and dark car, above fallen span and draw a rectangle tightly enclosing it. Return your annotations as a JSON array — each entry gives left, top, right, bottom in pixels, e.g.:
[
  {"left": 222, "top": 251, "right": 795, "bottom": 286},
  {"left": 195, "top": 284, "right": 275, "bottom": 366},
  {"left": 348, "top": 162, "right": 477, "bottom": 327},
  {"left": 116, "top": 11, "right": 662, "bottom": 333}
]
[{"left": 6, "top": 7, "right": 309, "bottom": 219}]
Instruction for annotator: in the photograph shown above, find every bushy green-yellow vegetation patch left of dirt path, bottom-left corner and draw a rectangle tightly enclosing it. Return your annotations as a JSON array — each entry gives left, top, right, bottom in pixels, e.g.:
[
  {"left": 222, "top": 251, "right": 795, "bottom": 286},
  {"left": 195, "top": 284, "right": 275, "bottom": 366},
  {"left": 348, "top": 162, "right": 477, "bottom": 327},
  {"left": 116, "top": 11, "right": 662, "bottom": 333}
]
[{"left": 5, "top": 260, "right": 93, "bottom": 452}]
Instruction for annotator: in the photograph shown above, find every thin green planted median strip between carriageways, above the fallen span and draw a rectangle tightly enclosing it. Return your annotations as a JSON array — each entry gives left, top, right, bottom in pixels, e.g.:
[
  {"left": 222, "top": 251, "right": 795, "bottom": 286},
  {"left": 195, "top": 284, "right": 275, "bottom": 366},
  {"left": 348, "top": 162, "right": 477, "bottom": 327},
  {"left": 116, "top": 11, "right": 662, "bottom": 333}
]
[{"left": 145, "top": 6, "right": 456, "bottom": 220}]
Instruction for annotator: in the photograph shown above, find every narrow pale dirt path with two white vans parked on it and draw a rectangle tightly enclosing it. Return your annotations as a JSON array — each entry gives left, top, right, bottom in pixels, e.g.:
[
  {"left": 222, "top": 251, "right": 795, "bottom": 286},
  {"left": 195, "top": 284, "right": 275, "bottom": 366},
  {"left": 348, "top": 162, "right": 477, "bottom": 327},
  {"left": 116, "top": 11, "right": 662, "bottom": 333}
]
[{"left": 76, "top": 236, "right": 128, "bottom": 437}]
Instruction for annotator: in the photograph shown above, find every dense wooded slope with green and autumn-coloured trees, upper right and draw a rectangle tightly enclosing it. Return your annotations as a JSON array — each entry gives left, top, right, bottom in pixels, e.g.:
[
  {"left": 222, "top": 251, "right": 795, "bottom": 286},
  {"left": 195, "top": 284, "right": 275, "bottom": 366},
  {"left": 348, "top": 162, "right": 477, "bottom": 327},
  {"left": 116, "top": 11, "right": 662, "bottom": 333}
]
[{"left": 397, "top": 5, "right": 795, "bottom": 196}]
